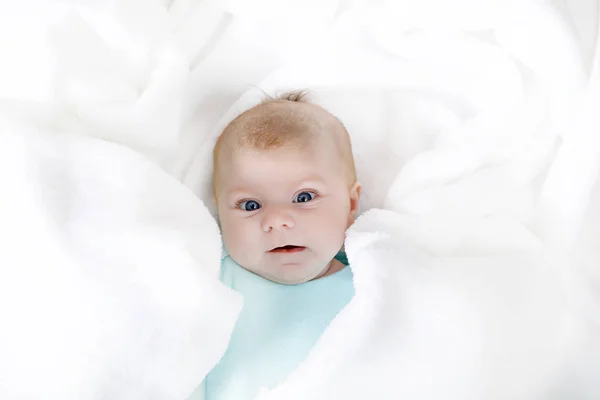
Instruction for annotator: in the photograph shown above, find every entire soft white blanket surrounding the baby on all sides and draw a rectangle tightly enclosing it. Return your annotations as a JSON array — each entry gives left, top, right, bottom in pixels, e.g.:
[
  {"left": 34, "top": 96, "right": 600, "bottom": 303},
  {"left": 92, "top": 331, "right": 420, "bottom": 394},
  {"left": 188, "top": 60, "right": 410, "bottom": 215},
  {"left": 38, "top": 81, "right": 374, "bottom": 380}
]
[{"left": 0, "top": 0, "right": 600, "bottom": 400}]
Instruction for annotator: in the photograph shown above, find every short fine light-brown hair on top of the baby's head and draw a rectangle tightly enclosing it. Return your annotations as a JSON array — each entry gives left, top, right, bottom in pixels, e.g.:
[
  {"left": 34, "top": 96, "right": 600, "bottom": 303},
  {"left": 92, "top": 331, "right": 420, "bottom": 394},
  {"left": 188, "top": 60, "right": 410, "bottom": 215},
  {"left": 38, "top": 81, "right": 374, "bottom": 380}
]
[{"left": 213, "top": 90, "right": 356, "bottom": 192}]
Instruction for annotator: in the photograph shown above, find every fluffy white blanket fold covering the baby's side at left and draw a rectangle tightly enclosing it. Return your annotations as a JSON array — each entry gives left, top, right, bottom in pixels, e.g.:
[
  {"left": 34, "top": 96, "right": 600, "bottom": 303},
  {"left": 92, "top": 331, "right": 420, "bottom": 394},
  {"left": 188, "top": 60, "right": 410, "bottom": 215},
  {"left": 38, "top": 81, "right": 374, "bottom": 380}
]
[{"left": 0, "top": 117, "right": 241, "bottom": 400}]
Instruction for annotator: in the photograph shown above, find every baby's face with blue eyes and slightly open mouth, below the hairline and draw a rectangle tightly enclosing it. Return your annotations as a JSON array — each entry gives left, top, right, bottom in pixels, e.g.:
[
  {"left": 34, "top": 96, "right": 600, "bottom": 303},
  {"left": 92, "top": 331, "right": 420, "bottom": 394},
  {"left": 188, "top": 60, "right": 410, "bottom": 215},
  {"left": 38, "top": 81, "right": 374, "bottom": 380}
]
[{"left": 216, "top": 145, "right": 360, "bottom": 284}]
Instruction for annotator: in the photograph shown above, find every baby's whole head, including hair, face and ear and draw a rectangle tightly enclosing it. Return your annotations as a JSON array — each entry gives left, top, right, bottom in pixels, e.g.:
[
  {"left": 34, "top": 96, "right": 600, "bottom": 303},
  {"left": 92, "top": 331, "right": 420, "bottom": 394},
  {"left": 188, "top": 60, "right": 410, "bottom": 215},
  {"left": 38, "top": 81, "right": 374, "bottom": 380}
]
[{"left": 213, "top": 92, "right": 360, "bottom": 284}]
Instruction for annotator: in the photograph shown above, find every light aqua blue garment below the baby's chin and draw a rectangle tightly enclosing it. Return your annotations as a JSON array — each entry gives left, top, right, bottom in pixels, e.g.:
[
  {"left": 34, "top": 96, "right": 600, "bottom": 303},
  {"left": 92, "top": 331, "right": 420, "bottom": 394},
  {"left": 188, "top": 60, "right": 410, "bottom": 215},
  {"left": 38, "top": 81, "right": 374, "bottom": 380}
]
[{"left": 204, "top": 253, "right": 354, "bottom": 400}]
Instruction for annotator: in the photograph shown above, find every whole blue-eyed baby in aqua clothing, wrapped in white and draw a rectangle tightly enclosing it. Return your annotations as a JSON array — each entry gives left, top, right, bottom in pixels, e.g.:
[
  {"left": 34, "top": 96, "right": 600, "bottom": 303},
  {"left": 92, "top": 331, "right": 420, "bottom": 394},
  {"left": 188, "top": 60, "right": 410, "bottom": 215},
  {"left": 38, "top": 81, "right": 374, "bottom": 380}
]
[{"left": 204, "top": 92, "right": 361, "bottom": 400}]
